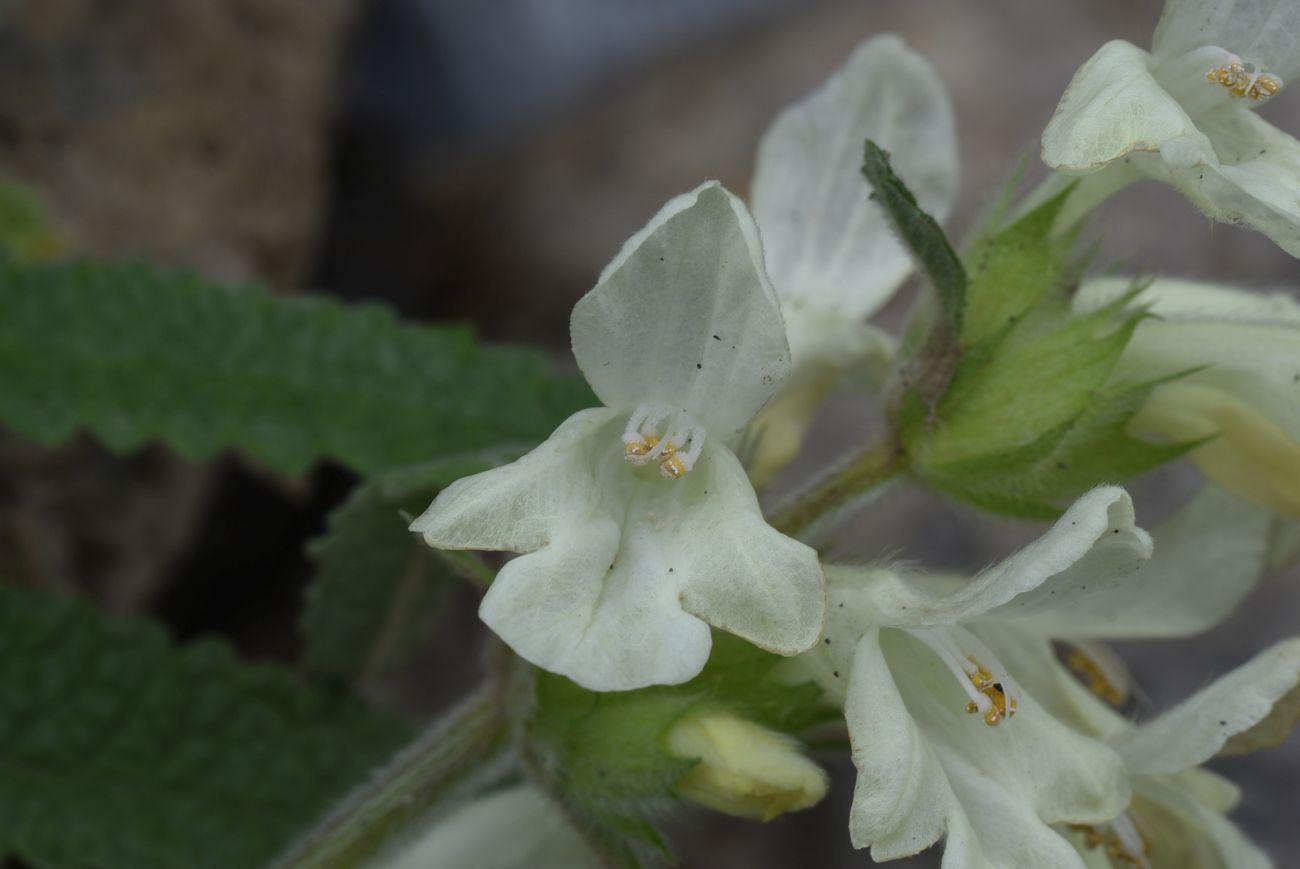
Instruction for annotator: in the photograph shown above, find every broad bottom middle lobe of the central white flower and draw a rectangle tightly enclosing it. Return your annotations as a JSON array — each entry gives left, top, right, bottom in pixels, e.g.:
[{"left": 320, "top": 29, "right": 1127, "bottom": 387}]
[{"left": 478, "top": 514, "right": 712, "bottom": 691}]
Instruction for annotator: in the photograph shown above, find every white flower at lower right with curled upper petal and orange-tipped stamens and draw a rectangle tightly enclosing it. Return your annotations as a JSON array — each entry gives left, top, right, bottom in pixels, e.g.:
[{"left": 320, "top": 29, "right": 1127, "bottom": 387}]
[{"left": 798, "top": 487, "right": 1151, "bottom": 869}]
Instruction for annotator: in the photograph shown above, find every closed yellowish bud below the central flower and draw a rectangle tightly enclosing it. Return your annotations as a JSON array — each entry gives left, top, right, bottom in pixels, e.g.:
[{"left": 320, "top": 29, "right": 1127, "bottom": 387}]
[{"left": 667, "top": 713, "right": 827, "bottom": 821}]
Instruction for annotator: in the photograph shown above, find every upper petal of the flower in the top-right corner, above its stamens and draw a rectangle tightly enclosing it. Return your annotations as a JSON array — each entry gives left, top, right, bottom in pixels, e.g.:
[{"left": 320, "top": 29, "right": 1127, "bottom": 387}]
[{"left": 1152, "top": 0, "right": 1300, "bottom": 82}]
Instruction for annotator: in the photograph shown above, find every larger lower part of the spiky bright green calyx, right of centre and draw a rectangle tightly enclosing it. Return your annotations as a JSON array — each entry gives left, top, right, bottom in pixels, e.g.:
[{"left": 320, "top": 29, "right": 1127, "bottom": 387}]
[{"left": 894, "top": 261, "right": 1187, "bottom": 519}]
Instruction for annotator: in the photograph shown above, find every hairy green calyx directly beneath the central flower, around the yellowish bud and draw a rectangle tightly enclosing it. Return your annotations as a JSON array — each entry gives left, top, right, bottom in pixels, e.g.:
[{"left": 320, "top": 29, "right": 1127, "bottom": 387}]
[{"left": 528, "top": 631, "right": 836, "bottom": 866}]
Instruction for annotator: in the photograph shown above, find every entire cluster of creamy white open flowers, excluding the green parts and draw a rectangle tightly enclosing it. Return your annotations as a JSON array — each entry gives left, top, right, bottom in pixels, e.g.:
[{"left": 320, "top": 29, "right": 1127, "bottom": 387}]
[{"left": 412, "top": 0, "right": 1300, "bottom": 869}]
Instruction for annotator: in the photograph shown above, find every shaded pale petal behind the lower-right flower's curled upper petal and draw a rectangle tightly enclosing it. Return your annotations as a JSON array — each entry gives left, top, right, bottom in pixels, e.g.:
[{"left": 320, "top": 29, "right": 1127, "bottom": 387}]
[{"left": 1023, "top": 487, "right": 1271, "bottom": 639}]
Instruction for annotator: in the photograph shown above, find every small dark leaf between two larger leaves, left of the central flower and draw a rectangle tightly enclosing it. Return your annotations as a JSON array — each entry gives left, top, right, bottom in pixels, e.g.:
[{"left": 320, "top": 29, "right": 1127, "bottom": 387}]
[{"left": 302, "top": 445, "right": 528, "bottom": 682}]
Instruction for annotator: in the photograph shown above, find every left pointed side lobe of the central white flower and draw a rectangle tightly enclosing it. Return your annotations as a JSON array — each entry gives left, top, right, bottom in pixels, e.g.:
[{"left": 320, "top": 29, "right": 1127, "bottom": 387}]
[{"left": 411, "top": 407, "right": 620, "bottom": 552}]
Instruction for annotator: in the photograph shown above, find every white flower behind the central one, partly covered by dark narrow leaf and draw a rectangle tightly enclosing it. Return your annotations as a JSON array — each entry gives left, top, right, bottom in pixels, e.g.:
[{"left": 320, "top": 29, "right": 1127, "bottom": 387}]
[{"left": 751, "top": 35, "right": 958, "bottom": 480}]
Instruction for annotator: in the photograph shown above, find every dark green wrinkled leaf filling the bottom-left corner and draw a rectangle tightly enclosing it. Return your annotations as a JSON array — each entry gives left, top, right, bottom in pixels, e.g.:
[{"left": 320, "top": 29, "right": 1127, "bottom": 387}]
[{"left": 0, "top": 584, "right": 406, "bottom": 869}]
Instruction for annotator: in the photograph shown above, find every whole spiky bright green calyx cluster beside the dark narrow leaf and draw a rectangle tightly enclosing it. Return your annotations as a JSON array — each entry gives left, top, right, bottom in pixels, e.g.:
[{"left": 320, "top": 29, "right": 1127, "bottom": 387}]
[{"left": 892, "top": 189, "right": 1192, "bottom": 519}]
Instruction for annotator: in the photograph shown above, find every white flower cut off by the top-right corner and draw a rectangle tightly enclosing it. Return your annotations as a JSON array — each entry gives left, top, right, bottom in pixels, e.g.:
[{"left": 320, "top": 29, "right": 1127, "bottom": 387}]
[{"left": 1043, "top": 0, "right": 1300, "bottom": 255}]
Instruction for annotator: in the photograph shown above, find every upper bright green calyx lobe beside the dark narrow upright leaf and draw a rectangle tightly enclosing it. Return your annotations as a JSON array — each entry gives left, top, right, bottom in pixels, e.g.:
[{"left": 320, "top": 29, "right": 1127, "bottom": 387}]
[{"left": 962, "top": 185, "right": 1076, "bottom": 346}]
